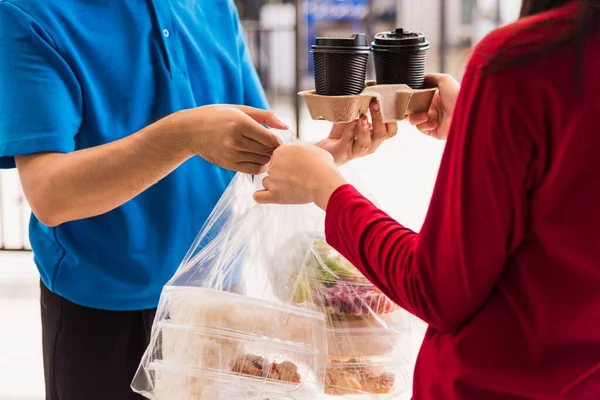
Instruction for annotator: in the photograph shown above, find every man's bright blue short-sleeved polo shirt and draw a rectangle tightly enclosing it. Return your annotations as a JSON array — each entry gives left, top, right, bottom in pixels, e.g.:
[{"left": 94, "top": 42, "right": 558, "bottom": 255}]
[{"left": 0, "top": 0, "right": 267, "bottom": 310}]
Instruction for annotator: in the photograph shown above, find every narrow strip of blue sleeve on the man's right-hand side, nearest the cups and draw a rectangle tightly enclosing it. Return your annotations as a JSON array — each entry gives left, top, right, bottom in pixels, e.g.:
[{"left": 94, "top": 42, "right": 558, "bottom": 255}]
[{"left": 231, "top": 0, "right": 269, "bottom": 110}]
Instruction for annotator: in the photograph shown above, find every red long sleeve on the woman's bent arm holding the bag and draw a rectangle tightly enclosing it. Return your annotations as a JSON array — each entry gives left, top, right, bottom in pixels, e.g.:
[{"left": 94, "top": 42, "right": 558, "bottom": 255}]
[{"left": 325, "top": 61, "right": 535, "bottom": 331}]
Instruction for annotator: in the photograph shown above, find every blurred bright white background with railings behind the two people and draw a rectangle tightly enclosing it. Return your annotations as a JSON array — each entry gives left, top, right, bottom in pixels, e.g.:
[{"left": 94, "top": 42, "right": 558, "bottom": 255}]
[{"left": 0, "top": 0, "right": 521, "bottom": 400}]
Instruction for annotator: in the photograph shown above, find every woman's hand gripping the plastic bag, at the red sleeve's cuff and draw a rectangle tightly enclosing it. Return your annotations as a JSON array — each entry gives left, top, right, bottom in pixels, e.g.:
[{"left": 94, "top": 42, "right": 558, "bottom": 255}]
[{"left": 254, "top": 144, "right": 346, "bottom": 210}]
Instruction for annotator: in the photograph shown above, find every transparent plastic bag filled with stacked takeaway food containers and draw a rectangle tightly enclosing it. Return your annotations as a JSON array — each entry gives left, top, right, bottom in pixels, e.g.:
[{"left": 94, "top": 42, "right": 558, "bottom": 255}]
[{"left": 132, "top": 132, "right": 410, "bottom": 400}]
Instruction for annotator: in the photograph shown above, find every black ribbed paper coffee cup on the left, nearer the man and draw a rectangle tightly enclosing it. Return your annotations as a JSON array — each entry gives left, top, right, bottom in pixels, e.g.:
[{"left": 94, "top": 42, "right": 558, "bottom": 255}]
[{"left": 311, "top": 34, "right": 371, "bottom": 96}]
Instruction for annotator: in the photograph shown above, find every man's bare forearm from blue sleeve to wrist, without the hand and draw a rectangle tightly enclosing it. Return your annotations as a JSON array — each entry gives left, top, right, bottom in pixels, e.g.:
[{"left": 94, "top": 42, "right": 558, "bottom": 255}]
[{"left": 15, "top": 115, "right": 193, "bottom": 226}]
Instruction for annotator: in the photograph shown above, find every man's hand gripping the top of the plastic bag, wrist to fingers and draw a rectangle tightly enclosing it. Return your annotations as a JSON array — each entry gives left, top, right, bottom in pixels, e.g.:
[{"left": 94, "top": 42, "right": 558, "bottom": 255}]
[{"left": 176, "top": 105, "right": 288, "bottom": 175}]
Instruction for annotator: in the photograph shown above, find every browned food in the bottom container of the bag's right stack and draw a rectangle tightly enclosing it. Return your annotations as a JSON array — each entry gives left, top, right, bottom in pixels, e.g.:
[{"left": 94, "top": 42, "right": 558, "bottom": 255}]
[{"left": 325, "top": 359, "right": 396, "bottom": 396}]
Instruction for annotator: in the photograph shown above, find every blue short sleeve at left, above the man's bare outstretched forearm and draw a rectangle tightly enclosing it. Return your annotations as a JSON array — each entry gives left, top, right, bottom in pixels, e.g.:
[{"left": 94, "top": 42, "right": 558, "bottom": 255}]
[{"left": 0, "top": 1, "right": 82, "bottom": 168}]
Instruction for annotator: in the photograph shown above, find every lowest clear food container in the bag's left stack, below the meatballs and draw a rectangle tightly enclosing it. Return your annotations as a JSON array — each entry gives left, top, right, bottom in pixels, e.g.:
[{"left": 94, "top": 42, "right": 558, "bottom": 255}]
[{"left": 148, "top": 362, "right": 323, "bottom": 400}]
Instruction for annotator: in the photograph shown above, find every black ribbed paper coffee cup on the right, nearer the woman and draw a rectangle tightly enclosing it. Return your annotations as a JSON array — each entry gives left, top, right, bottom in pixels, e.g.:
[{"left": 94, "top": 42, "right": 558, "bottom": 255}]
[{"left": 371, "top": 28, "right": 430, "bottom": 89}]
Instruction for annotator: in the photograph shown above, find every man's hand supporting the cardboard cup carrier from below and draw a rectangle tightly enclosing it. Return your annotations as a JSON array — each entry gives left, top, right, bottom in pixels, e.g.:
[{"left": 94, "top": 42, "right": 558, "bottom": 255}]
[{"left": 317, "top": 101, "right": 398, "bottom": 165}]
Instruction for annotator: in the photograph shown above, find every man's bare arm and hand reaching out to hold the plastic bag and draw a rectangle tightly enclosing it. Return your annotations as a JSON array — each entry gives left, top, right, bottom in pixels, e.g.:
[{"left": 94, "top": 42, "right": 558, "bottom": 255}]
[{"left": 15, "top": 106, "right": 285, "bottom": 226}]
